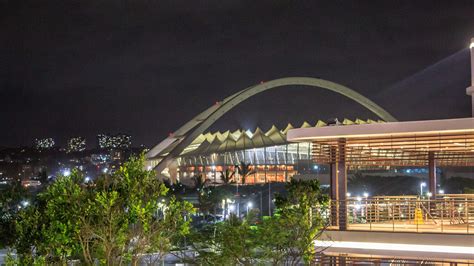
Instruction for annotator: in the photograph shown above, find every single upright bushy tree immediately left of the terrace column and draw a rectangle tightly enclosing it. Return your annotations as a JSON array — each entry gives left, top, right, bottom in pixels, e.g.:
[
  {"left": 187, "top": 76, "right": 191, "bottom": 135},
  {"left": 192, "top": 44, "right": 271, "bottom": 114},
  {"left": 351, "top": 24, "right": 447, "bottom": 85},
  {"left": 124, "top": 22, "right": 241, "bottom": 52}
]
[{"left": 258, "top": 180, "right": 328, "bottom": 265}]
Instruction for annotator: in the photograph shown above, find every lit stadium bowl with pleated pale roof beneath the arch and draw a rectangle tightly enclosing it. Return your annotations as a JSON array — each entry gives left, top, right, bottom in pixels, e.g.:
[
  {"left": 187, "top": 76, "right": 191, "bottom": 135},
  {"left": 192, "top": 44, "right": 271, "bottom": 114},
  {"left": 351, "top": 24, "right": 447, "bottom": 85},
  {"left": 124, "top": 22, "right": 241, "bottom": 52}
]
[{"left": 163, "top": 119, "right": 383, "bottom": 184}]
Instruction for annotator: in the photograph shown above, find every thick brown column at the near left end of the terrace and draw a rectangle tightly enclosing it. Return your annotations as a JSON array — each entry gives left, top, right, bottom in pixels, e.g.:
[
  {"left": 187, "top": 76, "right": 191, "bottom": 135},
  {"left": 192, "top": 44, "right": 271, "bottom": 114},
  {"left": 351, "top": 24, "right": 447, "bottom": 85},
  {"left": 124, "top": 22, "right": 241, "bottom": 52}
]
[{"left": 337, "top": 139, "right": 347, "bottom": 231}]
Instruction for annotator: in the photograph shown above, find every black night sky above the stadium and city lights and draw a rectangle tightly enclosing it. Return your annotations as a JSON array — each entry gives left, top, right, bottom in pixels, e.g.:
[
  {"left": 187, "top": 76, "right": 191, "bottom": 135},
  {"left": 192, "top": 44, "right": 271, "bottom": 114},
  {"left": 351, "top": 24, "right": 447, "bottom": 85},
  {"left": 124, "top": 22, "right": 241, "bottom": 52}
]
[{"left": 0, "top": 0, "right": 474, "bottom": 146}]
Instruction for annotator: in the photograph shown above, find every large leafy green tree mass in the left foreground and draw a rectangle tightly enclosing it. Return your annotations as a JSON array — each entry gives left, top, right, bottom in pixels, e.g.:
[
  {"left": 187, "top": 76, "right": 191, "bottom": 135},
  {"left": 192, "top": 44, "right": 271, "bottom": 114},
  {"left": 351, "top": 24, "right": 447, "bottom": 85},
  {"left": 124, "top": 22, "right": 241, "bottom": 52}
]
[{"left": 15, "top": 155, "right": 194, "bottom": 265}]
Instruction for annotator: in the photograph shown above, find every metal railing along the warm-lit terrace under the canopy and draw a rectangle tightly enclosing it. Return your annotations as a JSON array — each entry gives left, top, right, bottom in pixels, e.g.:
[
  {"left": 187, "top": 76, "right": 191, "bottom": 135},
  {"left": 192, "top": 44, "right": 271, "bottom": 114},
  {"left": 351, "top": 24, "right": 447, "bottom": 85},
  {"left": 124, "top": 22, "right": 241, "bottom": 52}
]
[{"left": 330, "top": 195, "right": 474, "bottom": 234}]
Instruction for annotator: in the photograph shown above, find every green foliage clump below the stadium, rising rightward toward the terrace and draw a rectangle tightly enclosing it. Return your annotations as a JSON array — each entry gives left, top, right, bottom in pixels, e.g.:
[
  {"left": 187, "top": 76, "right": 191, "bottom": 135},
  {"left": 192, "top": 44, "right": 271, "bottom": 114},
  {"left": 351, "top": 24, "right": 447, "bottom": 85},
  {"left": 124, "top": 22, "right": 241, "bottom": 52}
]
[{"left": 193, "top": 180, "right": 328, "bottom": 265}]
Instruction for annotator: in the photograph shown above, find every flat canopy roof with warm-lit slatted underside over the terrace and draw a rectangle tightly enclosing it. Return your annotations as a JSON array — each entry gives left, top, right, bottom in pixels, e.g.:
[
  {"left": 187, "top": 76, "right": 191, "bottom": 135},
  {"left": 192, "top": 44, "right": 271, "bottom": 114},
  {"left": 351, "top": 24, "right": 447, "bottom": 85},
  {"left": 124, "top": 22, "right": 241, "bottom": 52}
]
[{"left": 288, "top": 118, "right": 474, "bottom": 166}]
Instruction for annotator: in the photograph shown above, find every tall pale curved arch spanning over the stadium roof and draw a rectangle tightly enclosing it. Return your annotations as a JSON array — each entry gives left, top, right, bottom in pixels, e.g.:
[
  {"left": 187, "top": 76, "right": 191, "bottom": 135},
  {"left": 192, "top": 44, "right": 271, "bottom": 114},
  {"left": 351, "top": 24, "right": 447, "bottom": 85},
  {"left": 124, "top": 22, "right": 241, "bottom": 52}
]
[{"left": 146, "top": 77, "right": 397, "bottom": 177}]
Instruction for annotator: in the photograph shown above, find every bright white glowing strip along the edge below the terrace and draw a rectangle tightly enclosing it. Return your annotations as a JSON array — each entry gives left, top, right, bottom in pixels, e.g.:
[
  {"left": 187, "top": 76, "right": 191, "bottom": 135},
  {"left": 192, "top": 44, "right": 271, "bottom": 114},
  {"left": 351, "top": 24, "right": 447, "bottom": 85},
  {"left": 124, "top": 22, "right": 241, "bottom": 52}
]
[{"left": 314, "top": 240, "right": 473, "bottom": 255}]
